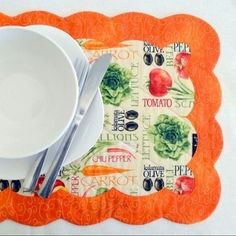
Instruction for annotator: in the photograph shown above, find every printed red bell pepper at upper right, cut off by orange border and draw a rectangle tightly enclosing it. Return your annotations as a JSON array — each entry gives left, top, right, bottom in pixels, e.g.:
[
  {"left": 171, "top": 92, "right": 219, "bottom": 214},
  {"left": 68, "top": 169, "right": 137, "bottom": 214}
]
[{"left": 174, "top": 52, "right": 191, "bottom": 79}]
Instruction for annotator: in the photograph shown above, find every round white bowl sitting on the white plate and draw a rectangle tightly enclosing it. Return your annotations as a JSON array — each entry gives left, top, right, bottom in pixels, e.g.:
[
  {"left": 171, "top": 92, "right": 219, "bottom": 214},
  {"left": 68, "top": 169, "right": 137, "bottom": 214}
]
[{"left": 0, "top": 27, "right": 78, "bottom": 158}]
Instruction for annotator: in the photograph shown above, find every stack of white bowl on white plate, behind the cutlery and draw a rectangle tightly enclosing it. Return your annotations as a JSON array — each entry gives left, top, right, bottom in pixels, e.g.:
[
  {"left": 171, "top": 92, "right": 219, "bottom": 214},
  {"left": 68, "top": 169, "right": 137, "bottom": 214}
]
[{"left": 0, "top": 25, "right": 104, "bottom": 179}]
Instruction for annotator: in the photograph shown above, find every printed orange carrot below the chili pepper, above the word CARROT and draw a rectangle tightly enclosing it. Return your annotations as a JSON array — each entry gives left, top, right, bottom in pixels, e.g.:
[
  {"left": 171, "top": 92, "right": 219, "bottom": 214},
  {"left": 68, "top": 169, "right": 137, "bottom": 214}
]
[{"left": 81, "top": 165, "right": 130, "bottom": 176}]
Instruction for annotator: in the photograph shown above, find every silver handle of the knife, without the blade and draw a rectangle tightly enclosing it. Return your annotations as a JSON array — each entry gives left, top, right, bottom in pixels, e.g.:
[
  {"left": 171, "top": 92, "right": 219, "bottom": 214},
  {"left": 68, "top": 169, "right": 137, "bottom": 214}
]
[{"left": 38, "top": 122, "right": 79, "bottom": 198}]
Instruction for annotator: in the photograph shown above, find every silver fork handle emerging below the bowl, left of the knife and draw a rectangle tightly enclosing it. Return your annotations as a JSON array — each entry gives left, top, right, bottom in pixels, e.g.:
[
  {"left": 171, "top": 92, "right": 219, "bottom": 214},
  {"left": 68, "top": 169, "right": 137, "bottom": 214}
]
[{"left": 23, "top": 149, "right": 48, "bottom": 192}]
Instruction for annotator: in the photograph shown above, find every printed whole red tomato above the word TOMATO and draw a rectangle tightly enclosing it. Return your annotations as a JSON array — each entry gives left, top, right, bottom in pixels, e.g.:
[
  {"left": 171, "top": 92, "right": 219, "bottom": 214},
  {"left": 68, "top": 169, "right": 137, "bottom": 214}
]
[{"left": 149, "top": 68, "right": 172, "bottom": 97}]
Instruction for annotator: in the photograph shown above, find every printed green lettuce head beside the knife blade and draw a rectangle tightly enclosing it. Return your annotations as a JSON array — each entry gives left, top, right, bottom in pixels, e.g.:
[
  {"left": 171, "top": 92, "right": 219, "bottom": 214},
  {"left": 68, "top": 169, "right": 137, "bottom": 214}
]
[{"left": 100, "top": 63, "right": 132, "bottom": 106}]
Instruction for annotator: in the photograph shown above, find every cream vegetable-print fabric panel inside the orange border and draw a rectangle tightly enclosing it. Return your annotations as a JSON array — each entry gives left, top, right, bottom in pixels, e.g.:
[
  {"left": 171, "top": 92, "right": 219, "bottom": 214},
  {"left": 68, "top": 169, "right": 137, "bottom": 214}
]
[{"left": 60, "top": 39, "right": 197, "bottom": 196}]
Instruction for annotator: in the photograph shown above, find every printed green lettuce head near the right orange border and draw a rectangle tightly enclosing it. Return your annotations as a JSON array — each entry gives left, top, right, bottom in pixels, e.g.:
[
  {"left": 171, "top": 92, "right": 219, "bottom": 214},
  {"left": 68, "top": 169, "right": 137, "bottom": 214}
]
[{"left": 149, "top": 114, "right": 190, "bottom": 160}]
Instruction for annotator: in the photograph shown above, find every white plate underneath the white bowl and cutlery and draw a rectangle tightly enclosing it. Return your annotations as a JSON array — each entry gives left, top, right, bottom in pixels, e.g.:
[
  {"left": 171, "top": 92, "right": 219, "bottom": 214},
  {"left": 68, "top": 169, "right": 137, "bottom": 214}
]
[{"left": 0, "top": 26, "right": 104, "bottom": 179}]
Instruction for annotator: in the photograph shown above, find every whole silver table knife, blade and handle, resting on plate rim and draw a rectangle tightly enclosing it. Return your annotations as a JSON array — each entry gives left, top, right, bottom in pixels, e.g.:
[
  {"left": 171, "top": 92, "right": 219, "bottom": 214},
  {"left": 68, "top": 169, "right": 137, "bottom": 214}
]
[{"left": 38, "top": 54, "right": 112, "bottom": 198}]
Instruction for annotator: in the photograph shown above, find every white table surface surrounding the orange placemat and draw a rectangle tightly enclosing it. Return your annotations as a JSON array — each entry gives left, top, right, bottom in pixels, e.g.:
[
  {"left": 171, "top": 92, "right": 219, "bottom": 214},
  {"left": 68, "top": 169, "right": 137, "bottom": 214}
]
[{"left": 0, "top": 0, "right": 236, "bottom": 235}]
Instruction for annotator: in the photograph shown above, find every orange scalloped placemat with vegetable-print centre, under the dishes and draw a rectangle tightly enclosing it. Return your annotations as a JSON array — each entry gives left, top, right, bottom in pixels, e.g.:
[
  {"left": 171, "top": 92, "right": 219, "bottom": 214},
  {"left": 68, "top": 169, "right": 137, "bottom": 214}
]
[{"left": 0, "top": 12, "right": 223, "bottom": 226}]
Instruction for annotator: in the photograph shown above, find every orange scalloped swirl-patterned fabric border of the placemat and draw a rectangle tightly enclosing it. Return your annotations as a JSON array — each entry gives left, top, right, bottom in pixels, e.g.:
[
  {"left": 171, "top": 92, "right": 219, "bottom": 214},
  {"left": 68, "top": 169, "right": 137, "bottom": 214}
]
[{"left": 0, "top": 11, "right": 223, "bottom": 226}]
